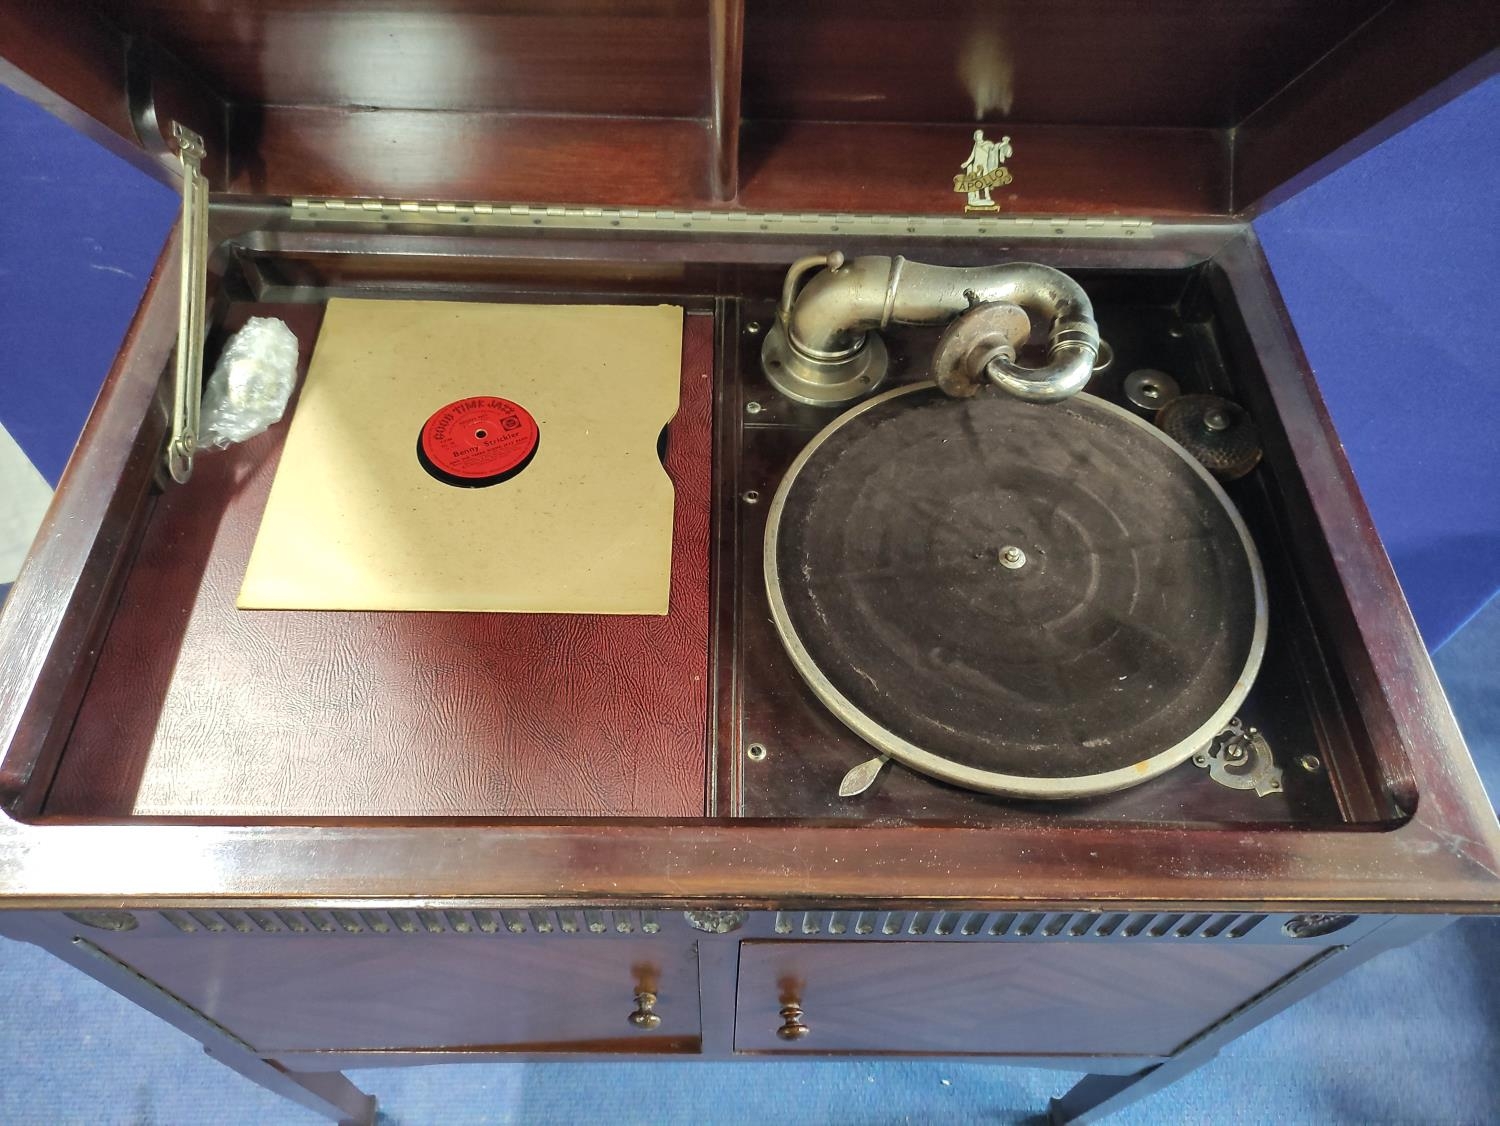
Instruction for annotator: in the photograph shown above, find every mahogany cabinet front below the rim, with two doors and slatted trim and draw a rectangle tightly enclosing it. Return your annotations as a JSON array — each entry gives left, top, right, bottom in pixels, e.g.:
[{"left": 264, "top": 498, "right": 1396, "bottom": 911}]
[{"left": 5, "top": 907, "right": 1404, "bottom": 1117}]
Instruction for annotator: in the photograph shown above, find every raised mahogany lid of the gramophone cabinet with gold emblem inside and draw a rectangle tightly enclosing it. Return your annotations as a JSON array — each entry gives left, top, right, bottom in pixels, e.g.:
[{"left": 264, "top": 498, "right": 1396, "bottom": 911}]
[{"left": 0, "top": 0, "right": 1500, "bottom": 216}]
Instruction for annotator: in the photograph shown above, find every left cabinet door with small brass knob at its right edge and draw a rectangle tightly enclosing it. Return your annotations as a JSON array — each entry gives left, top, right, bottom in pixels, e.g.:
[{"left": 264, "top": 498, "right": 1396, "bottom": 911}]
[{"left": 98, "top": 933, "right": 699, "bottom": 1056}]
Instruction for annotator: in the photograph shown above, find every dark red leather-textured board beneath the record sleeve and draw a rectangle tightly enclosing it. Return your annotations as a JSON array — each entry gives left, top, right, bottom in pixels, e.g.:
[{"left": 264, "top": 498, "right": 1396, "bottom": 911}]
[{"left": 45, "top": 306, "right": 713, "bottom": 817}]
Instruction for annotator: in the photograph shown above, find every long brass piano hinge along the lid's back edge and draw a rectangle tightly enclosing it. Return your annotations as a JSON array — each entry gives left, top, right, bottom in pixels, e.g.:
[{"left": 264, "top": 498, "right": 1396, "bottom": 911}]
[{"left": 291, "top": 199, "right": 1152, "bottom": 238}]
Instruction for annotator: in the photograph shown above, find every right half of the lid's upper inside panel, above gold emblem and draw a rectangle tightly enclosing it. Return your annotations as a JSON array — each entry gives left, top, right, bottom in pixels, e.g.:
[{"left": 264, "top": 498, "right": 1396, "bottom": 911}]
[{"left": 746, "top": 0, "right": 1386, "bottom": 129}]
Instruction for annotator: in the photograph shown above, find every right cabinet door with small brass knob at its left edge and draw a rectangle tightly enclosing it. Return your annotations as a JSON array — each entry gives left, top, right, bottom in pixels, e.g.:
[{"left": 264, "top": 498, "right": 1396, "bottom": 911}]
[{"left": 735, "top": 942, "right": 1310, "bottom": 1056}]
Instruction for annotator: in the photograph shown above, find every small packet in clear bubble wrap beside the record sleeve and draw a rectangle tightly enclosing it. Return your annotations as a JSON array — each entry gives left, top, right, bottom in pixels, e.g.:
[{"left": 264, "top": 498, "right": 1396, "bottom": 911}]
[{"left": 198, "top": 316, "right": 297, "bottom": 450}]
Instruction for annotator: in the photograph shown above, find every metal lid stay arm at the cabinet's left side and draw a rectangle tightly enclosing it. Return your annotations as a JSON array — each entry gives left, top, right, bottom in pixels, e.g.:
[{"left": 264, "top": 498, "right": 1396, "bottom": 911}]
[{"left": 167, "top": 121, "right": 209, "bottom": 484}]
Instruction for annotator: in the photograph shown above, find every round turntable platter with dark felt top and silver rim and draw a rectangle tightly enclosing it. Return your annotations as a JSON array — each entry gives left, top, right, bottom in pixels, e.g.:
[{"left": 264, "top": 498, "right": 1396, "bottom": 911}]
[{"left": 765, "top": 384, "right": 1266, "bottom": 798}]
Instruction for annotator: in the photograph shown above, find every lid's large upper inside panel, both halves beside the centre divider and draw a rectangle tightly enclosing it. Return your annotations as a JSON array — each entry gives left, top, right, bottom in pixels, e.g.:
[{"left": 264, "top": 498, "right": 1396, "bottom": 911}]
[{"left": 76, "top": 0, "right": 1385, "bottom": 127}]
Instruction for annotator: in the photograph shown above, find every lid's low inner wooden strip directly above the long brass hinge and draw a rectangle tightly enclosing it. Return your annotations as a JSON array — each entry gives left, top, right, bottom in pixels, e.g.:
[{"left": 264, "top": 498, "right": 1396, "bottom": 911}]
[{"left": 228, "top": 106, "right": 1230, "bottom": 214}]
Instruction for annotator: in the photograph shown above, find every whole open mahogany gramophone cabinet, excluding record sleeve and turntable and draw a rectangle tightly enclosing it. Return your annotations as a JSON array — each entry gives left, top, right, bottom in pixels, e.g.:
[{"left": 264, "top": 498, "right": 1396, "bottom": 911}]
[{"left": 0, "top": 0, "right": 1500, "bottom": 1122}]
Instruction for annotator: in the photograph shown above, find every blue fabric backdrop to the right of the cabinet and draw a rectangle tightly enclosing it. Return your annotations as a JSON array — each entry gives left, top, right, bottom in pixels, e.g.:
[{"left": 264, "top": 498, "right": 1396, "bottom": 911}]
[{"left": 1256, "top": 78, "right": 1500, "bottom": 649}]
